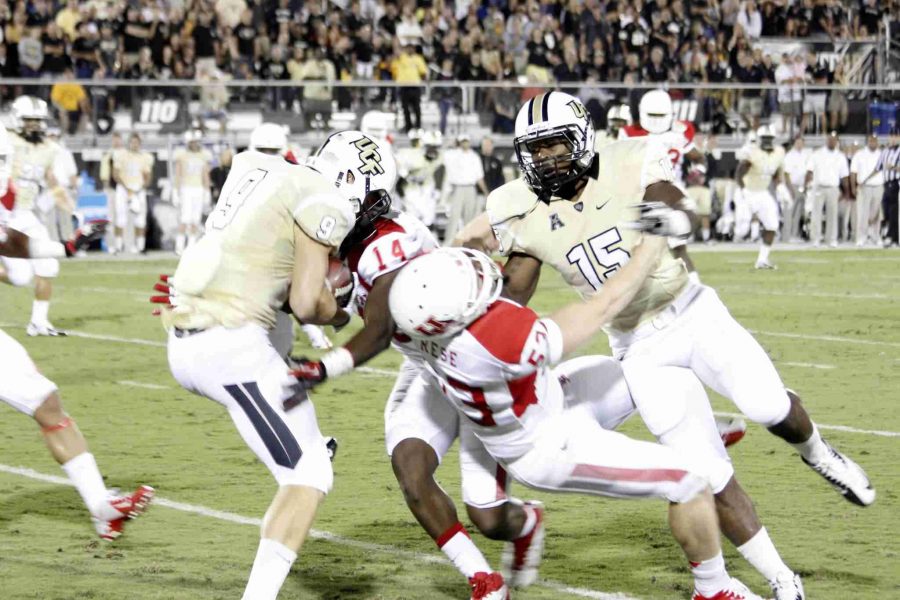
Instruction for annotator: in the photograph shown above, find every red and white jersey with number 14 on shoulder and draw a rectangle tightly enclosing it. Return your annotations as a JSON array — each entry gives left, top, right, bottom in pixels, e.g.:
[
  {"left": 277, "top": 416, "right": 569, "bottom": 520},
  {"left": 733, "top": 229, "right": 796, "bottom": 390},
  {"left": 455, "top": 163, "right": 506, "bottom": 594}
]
[{"left": 347, "top": 213, "right": 440, "bottom": 316}]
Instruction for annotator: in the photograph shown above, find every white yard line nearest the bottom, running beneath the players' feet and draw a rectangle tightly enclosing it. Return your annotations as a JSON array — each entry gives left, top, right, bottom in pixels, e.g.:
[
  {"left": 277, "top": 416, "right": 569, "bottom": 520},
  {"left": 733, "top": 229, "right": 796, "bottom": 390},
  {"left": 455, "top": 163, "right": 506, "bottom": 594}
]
[{"left": 0, "top": 464, "right": 637, "bottom": 600}]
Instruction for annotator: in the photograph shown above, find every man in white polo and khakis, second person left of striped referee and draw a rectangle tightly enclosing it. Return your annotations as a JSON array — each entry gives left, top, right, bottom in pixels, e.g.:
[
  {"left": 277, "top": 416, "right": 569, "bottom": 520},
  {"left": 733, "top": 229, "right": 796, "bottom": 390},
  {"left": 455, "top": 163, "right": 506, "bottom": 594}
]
[{"left": 806, "top": 131, "right": 850, "bottom": 248}]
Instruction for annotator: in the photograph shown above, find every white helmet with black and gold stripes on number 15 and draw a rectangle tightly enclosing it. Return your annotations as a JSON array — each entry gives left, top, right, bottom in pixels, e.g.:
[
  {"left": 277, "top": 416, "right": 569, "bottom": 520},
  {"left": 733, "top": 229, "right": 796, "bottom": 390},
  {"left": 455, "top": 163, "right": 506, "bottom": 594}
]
[{"left": 513, "top": 91, "right": 595, "bottom": 200}]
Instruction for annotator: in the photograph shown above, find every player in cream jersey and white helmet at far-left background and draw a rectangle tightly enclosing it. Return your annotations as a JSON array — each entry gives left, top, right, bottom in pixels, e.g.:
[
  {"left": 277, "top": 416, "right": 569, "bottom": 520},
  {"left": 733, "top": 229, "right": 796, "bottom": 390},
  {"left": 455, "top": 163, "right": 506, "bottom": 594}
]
[{"left": 0, "top": 96, "right": 65, "bottom": 336}]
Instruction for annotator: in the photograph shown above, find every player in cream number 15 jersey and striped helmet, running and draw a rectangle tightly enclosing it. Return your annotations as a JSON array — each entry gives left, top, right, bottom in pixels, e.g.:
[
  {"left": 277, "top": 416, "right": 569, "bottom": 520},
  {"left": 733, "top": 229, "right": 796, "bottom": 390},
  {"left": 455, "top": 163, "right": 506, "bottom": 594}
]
[{"left": 464, "top": 92, "right": 875, "bottom": 600}]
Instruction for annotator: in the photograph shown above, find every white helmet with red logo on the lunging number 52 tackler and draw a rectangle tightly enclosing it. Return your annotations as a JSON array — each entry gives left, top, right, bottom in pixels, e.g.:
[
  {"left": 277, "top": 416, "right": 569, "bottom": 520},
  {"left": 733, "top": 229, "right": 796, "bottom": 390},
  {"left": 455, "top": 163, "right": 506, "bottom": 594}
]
[{"left": 388, "top": 248, "right": 503, "bottom": 339}]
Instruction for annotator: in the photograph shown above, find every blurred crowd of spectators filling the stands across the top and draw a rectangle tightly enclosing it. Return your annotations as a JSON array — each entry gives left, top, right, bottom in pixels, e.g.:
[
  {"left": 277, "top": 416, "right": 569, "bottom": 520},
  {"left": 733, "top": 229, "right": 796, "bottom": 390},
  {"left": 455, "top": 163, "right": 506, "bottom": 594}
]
[{"left": 0, "top": 0, "right": 900, "bottom": 132}]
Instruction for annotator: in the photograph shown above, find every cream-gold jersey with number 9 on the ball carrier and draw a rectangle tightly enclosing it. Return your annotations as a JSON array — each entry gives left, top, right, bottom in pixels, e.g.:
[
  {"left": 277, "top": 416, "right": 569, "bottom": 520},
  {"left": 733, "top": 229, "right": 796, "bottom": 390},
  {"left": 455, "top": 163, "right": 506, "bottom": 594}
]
[{"left": 163, "top": 150, "right": 355, "bottom": 329}]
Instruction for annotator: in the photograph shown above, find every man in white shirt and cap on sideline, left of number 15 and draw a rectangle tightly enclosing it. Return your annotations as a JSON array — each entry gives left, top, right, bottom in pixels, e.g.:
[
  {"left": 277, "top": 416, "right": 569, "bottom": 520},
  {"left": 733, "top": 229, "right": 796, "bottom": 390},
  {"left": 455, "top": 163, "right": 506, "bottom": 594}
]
[{"left": 444, "top": 133, "right": 488, "bottom": 243}]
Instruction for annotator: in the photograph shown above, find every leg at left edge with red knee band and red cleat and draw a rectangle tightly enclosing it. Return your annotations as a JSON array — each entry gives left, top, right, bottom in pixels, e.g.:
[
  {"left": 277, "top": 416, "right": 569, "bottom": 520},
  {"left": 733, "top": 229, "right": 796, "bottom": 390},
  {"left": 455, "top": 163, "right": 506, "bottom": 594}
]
[{"left": 0, "top": 332, "right": 153, "bottom": 540}]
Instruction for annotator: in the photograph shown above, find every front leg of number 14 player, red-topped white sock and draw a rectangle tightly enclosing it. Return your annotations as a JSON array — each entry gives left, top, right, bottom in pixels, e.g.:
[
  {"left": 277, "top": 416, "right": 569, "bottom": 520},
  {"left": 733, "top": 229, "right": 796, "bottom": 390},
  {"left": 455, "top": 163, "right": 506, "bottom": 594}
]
[{"left": 384, "top": 361, "right": 502, "bottom": 596}]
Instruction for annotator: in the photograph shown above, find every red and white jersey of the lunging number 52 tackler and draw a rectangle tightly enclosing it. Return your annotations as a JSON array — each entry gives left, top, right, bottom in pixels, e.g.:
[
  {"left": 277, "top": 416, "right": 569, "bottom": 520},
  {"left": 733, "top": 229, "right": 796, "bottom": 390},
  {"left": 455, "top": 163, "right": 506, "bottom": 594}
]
[{"left": 399, "top": 299, "right": 564, "bottom": 460}]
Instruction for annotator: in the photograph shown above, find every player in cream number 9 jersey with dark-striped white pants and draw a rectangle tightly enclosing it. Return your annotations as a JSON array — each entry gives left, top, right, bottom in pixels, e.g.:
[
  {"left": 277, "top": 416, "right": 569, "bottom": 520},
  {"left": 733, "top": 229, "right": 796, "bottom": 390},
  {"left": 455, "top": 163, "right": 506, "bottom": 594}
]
[{"left": 162, "top": 123, "right": 353, "bottom": 600}]
